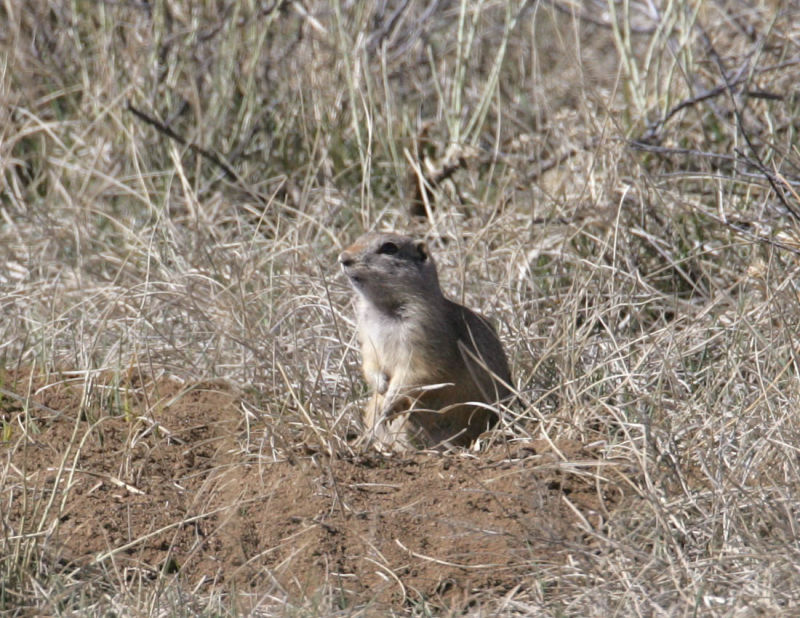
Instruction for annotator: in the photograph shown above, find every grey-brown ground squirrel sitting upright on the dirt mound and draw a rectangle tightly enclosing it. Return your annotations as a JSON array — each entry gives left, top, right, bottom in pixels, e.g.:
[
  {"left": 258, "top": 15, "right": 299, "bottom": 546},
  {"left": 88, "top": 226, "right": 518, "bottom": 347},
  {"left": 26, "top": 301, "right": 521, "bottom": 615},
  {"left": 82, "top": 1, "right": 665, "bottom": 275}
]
[{"left": 339, "top": 234, "right": 511, "bottom": 450}]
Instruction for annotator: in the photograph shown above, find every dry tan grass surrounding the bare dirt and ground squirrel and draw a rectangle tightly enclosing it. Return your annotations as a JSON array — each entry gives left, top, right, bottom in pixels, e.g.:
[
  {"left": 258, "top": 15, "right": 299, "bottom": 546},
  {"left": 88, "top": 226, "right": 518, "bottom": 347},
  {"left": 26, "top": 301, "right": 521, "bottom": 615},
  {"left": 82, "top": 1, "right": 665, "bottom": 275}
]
[{"left": 0, "top": 0, "right": 800, "bottom": 615}]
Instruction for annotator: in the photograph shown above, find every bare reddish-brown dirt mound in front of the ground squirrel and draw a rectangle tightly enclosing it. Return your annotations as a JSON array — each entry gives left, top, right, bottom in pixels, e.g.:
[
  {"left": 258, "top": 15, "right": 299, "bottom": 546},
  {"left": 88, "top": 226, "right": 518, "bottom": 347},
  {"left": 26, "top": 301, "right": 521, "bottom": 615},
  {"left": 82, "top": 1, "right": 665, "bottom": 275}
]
[{"left": 0, "top": 374, "right": 623, "bottom": 608}]
